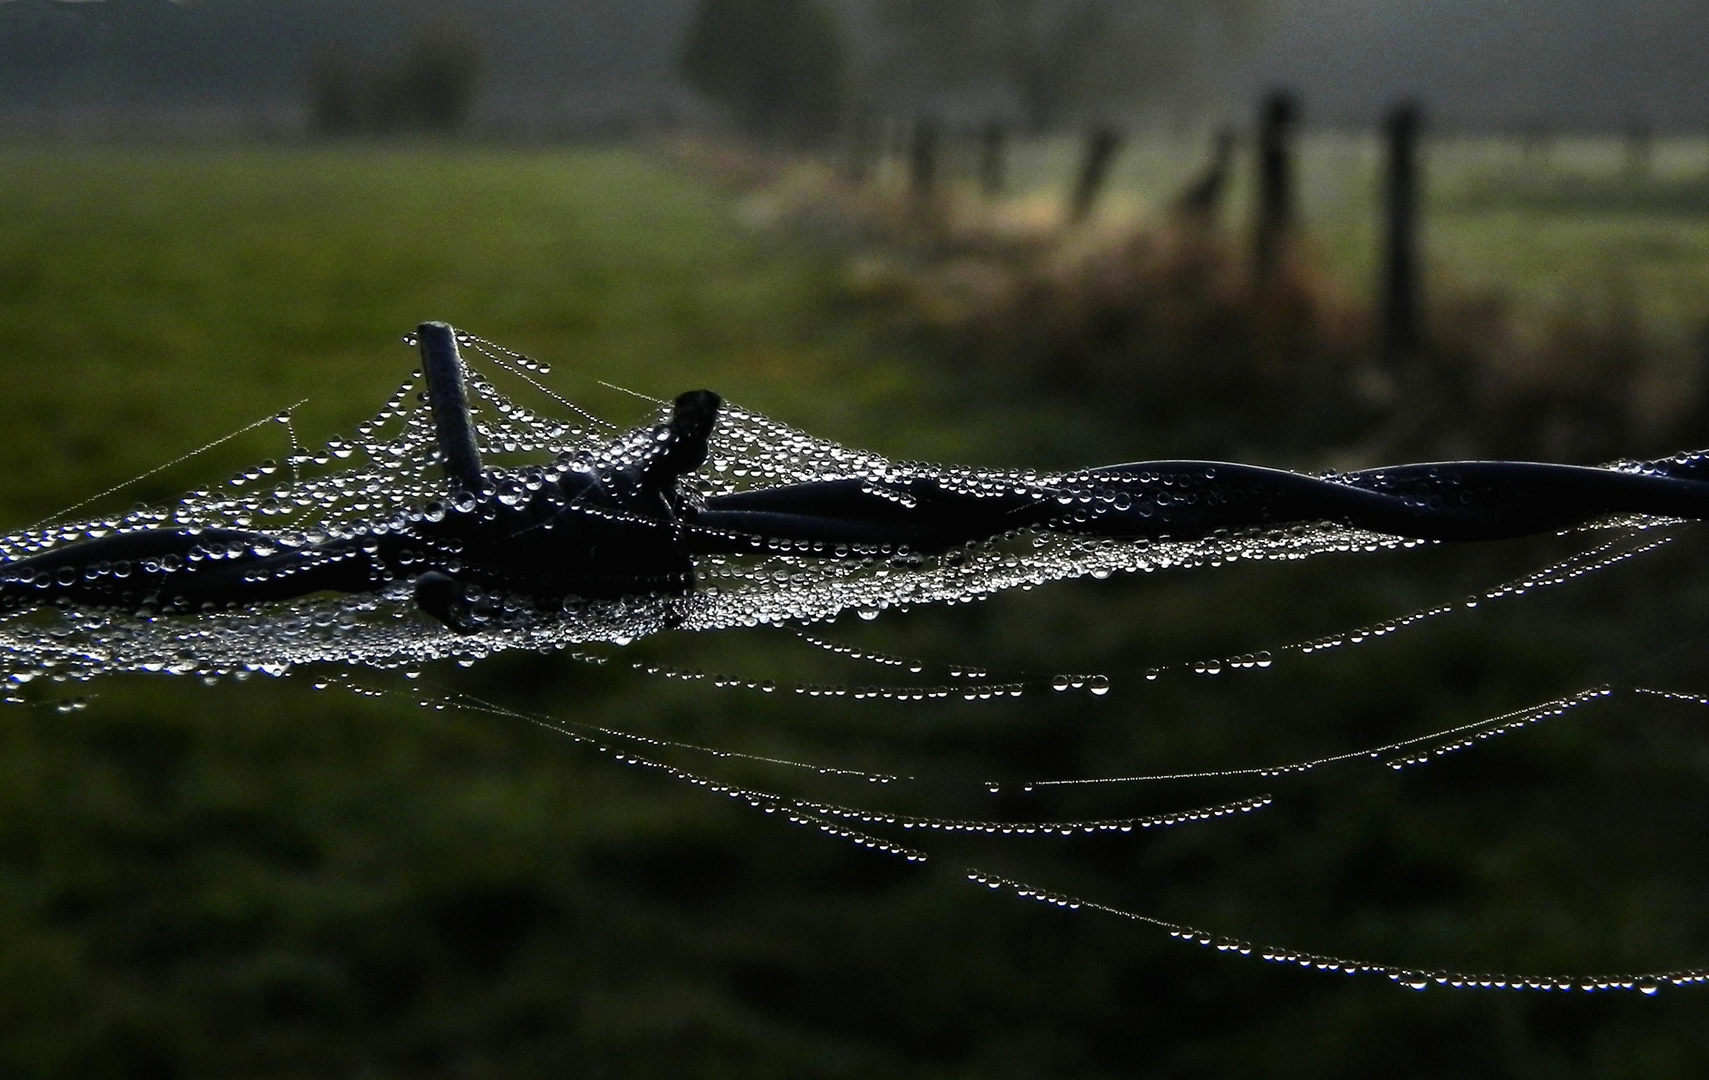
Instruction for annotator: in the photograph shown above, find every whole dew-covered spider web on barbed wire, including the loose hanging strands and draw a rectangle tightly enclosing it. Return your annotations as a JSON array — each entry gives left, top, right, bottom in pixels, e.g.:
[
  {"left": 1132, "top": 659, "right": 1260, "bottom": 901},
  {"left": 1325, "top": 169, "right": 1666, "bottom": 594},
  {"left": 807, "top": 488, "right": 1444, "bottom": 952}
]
[{"left": 0, "top": 335, "right": 1706, "bottom": 993}]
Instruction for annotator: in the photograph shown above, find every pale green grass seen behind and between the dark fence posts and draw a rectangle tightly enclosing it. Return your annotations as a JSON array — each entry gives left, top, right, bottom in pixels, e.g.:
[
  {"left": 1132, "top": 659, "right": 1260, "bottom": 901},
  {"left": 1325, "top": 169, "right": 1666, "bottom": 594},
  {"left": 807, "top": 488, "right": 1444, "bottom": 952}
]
[{"left": 916, "top": 130, "right": 1709, "bottom": 343}]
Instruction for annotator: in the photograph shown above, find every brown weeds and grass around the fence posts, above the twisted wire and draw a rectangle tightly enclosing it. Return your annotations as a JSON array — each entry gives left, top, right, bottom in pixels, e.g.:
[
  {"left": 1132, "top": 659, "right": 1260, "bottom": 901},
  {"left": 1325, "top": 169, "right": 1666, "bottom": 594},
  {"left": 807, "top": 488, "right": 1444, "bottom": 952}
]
[{"left": 830, "top": 132, "right": 1709, "bottom": 468}]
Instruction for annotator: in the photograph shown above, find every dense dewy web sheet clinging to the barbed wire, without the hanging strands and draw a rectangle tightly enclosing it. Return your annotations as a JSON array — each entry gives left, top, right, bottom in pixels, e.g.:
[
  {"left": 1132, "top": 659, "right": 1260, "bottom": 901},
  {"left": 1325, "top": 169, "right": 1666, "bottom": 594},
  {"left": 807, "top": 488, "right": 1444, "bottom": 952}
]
[{"left": 0, "top": 335, "right": 1456, "bottom": 682}]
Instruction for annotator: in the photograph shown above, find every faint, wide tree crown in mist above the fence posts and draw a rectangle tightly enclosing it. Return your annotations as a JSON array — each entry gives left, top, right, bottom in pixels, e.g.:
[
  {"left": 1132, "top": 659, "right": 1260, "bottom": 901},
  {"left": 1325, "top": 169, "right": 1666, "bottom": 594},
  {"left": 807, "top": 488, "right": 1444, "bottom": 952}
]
[{"left": 875, "top": 0, "right": 1263, "bottom": 130}]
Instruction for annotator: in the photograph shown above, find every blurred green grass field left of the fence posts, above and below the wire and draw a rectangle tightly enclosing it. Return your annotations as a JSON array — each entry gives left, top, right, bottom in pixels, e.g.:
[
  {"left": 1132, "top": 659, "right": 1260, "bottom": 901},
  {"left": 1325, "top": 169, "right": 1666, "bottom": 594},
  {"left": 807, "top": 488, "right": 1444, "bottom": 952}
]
[{"left": 0, "top": 145, "right": 1709, "bottom": 1078}]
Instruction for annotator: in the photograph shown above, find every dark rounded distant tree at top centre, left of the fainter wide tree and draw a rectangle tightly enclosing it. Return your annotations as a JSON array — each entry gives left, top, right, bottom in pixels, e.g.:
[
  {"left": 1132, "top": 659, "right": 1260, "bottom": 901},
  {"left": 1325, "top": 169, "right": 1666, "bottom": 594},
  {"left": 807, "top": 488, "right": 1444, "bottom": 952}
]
[{"left": 680, "top": 0, "right": 848, "bottom": 140}]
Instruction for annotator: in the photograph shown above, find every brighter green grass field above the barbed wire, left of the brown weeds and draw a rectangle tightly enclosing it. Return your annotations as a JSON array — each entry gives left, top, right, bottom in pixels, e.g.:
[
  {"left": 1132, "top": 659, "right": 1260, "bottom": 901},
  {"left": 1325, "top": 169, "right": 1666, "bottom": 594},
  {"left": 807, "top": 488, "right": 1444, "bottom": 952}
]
[{"left": 0, "top": 147, "right": 963, "bottom": 533}]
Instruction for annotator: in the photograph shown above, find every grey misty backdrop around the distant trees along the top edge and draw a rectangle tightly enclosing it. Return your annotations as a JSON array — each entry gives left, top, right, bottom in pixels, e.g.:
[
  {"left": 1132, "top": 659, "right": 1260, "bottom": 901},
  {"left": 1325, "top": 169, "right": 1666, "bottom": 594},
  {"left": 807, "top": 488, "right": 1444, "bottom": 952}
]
[{"left": 0, "top": 0, "right": 1709, "bottom": 132}]
